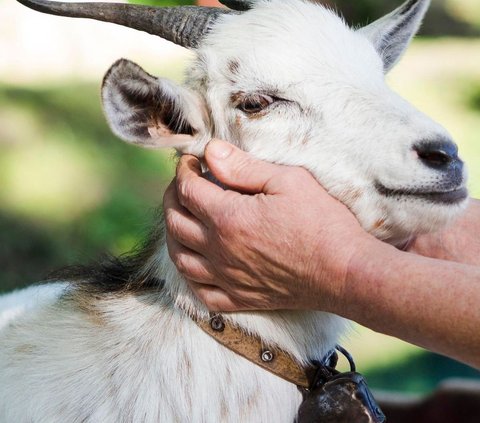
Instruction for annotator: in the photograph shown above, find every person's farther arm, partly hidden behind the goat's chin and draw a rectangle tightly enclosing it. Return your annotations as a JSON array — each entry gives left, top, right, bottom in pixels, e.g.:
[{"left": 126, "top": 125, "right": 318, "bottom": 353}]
[{"left": 410, "top": 199, "right": 480, "bottom": 266}]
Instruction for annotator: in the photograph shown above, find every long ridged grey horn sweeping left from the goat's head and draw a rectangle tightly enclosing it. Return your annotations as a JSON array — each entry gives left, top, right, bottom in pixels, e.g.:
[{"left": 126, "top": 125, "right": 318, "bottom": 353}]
[{"left": 18, "top": 0, "right": 237, "bottom": 48}]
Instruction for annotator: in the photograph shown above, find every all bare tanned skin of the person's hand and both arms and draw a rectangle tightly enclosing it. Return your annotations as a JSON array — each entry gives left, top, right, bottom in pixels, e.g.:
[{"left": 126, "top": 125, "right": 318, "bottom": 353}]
[{"left": 164, "top": 140, "right": 480, "bottom": 368}]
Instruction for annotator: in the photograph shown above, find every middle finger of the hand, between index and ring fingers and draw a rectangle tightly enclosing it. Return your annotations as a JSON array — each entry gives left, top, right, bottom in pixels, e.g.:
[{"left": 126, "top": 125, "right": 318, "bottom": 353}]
[{"left": 163, "top": 183, "right": 208, "bottom": 253}]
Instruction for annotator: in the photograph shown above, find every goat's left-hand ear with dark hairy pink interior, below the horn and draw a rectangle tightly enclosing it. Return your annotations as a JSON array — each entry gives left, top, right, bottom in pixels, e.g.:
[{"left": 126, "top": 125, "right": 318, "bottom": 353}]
[{"left": 102, "top": 59, "right": 205, "bottom": 150}]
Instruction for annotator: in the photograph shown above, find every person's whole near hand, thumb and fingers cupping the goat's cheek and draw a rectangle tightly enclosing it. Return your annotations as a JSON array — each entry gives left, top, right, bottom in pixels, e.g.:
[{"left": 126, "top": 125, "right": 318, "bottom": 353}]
[{"left": 164, "top": 140, "right": 371, "bottom": 312}]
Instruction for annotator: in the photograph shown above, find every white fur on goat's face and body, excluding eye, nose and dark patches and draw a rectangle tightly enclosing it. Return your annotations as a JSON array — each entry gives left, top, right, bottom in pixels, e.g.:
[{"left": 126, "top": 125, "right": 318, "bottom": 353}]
[{"left": 0, "top": 0, "right": 465, "bottom": 423}]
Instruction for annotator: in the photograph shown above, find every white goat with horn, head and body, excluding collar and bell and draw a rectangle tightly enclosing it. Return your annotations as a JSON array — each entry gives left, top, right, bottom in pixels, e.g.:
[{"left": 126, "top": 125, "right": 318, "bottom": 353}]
[{"left": 0, "top": 0, "right": 467, "bottom": 423}]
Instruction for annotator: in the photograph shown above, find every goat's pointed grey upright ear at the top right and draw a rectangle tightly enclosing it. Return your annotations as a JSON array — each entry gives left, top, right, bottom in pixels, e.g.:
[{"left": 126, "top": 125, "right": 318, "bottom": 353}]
[{"left": 359, "top": 0, "right": 430, "bottom": 73}]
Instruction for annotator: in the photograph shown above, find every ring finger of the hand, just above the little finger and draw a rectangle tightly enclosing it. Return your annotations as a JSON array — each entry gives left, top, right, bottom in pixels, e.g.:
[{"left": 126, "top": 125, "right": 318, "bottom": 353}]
[{"left": 167, "top": 233, "right": 215, "bottom": 284}]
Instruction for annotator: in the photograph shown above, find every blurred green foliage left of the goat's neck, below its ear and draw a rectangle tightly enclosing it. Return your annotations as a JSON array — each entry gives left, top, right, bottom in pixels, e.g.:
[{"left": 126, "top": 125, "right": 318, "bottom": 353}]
[{"left": 0, "top": 82, "right": 173, "bottom": 291}]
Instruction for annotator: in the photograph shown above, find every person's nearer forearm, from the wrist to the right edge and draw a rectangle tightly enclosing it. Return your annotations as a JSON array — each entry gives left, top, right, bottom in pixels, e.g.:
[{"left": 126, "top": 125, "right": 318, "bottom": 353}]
[{"left": 340, "top": 241, "right": 480, "bottom": 367}]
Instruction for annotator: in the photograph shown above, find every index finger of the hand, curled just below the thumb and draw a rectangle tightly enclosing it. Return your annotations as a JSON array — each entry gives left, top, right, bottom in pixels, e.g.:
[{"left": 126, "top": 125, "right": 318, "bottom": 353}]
[{"left": 176, "top": 155, "right": 229, "bottom": 224}]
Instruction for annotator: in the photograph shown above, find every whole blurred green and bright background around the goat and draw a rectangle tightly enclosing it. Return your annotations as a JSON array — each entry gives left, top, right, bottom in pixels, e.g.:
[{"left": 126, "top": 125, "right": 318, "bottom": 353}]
[{"left": 0, "top": 0, "right": 480, "bottom": 392}]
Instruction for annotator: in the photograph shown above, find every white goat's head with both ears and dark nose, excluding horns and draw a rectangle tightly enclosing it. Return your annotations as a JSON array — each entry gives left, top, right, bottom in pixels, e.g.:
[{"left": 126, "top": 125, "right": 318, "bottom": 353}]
[{"left": 103, "top": 0, "right": 467, "bottom": 247}]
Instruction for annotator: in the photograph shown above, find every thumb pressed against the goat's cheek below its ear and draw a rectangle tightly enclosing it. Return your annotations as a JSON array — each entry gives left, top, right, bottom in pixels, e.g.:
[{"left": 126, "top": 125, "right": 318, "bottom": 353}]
[{"left": 205, "top": 139, "right": 285, "bottom": 193}]
